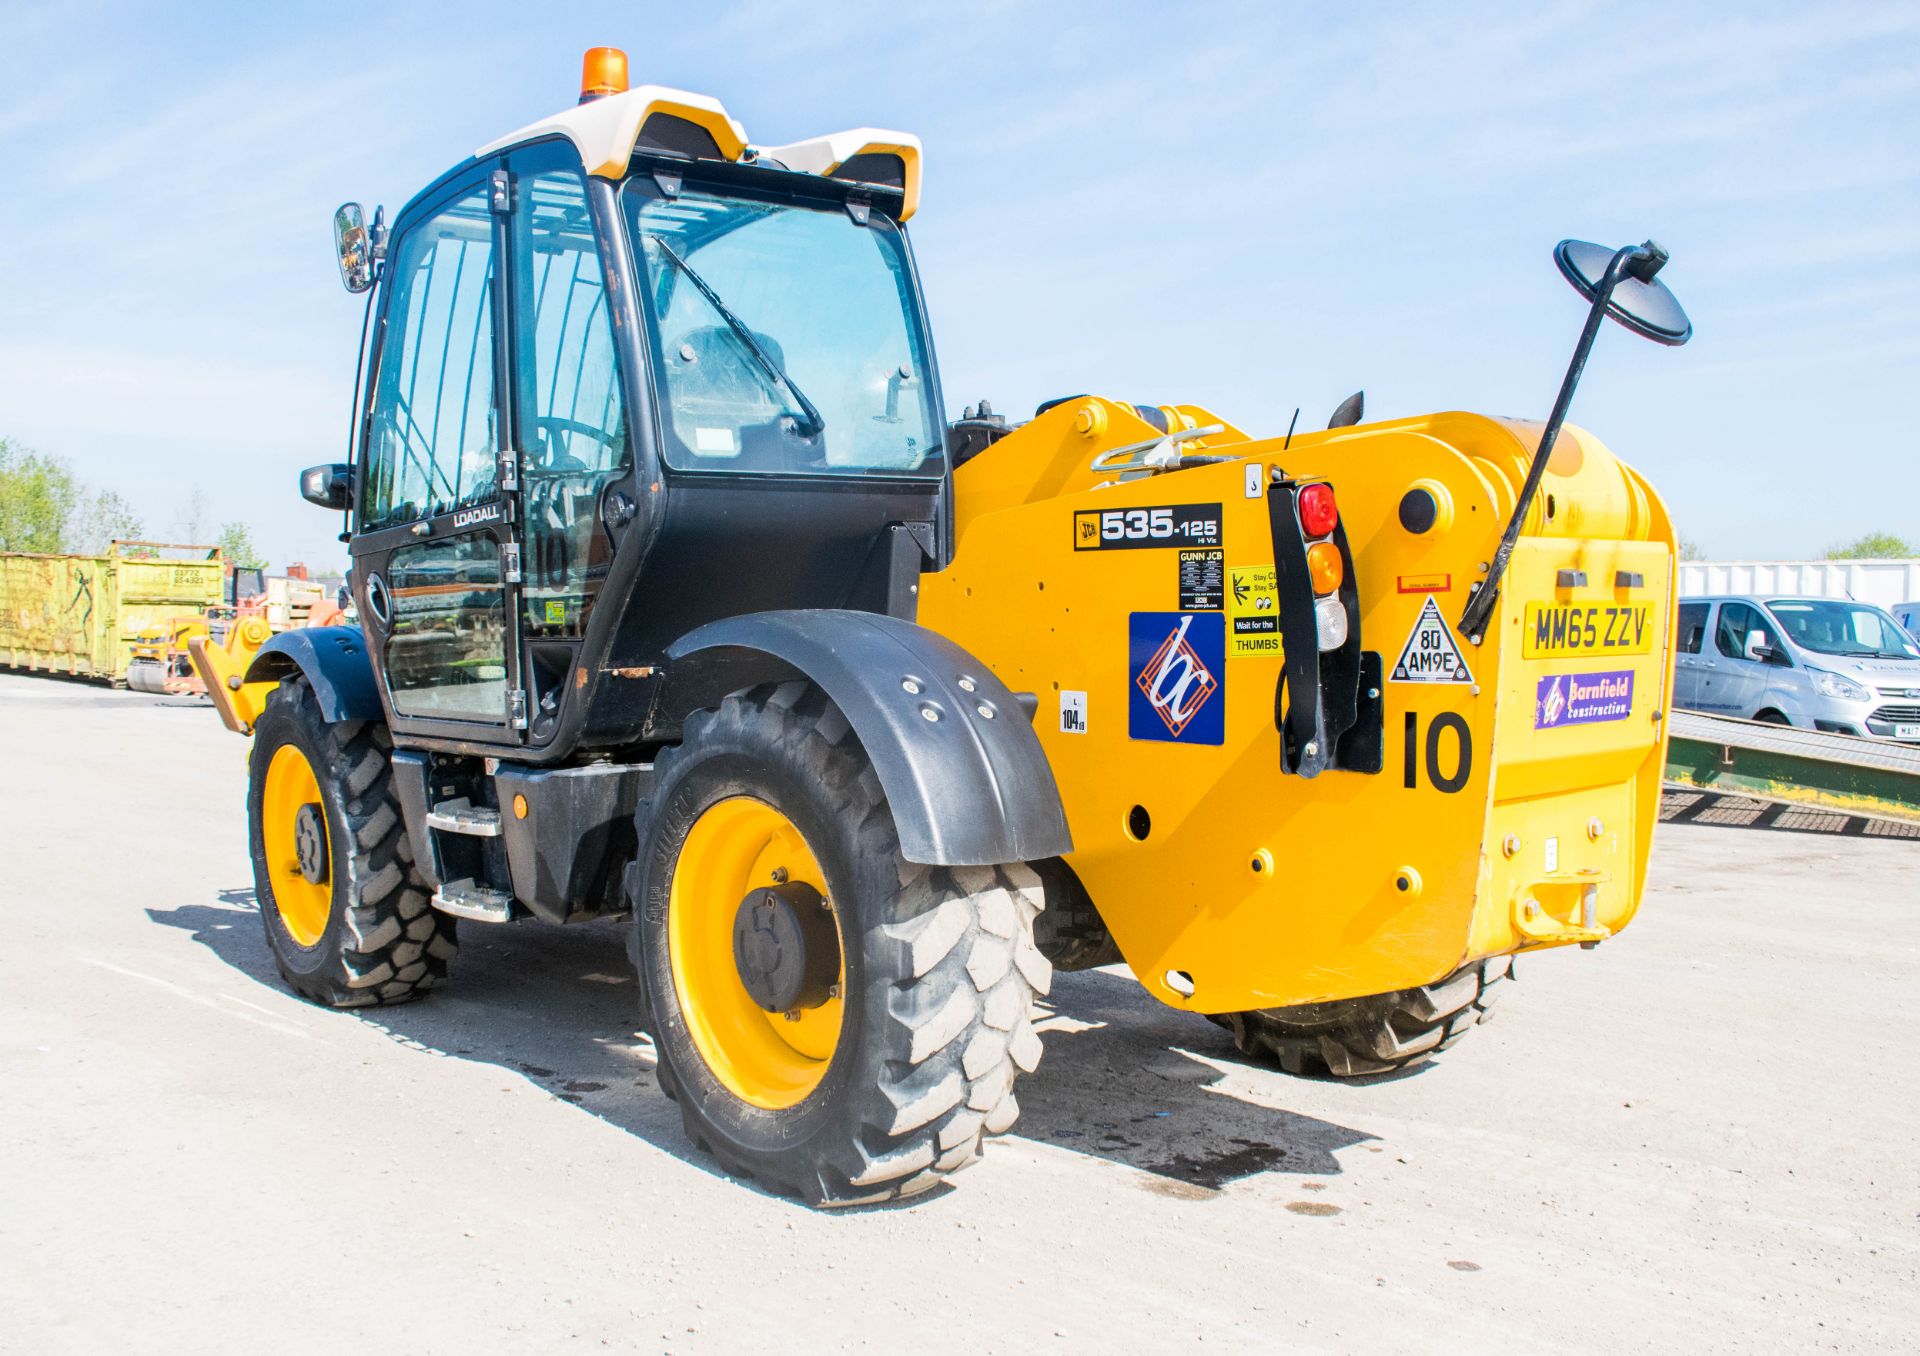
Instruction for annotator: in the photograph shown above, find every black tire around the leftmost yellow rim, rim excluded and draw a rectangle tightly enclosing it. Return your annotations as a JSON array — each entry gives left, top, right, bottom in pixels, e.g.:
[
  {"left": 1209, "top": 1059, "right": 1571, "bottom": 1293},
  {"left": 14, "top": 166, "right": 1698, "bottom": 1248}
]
[{"left": 248, "top": 674, "right": 459, "bottom": 1008}]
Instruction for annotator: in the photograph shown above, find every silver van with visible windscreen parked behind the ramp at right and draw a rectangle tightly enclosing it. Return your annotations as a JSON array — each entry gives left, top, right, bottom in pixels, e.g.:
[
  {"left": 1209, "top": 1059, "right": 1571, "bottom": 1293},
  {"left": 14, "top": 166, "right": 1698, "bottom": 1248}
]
[{"left": 1674, "top": 597, "right": 1920, "bottom": 741}]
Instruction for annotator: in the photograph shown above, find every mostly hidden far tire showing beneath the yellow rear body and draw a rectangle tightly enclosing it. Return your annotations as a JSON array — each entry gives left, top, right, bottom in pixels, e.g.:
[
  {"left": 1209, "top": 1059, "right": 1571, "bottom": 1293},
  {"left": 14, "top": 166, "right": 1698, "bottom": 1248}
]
[{"left": 1213, "top": 956, "right": 1513, "bottom": 1078}]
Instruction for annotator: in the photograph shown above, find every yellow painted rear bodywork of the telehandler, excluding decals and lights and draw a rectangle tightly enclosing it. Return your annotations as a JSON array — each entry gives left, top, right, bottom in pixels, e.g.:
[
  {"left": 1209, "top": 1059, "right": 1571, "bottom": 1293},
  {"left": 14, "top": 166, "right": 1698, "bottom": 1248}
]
[{"left": 920, "top": 398, "right": 1674, "bottom": 1012}]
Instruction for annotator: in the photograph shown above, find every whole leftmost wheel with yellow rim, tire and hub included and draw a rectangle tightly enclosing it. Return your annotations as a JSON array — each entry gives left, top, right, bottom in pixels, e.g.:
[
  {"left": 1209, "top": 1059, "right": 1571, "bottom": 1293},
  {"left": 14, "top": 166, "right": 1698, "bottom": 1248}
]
[{"left": 248, "top": 676, "right": 457, "bottom": 1008}]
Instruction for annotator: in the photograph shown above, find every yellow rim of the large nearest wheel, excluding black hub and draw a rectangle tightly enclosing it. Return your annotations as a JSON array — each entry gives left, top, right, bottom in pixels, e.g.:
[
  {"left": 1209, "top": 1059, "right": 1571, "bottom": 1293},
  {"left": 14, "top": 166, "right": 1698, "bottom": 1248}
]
[{"left": 666, "top": 795, "right": 847, "bottom": 1110}]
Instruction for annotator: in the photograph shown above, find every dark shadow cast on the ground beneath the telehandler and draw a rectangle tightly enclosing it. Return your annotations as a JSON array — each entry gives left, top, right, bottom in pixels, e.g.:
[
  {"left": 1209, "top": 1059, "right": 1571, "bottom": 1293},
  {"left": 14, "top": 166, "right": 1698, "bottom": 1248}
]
[{"left": 148, "top": 889, "right": 1371, "bottom": 1199}]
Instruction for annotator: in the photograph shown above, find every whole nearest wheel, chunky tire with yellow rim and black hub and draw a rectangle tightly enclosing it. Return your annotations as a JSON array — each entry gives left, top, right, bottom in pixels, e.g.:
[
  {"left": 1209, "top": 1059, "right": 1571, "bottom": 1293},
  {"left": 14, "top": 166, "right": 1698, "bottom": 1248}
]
[{"left": 630, "top": 684, "right": 1052, "bottom": 1206}]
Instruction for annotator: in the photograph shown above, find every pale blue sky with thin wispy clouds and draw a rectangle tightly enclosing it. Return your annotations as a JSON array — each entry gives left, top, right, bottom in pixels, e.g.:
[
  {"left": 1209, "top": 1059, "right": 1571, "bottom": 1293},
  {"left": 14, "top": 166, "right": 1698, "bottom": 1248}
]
[{"left": 0, "top": 0, "right": 1920, "bottom": 563}]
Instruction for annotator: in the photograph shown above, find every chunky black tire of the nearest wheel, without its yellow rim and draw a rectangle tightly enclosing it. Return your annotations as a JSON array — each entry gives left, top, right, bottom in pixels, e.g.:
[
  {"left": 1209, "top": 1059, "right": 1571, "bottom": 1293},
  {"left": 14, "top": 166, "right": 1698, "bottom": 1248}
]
[{"left": 628, "top": 682, "right": 1052, "bottom": 1206}]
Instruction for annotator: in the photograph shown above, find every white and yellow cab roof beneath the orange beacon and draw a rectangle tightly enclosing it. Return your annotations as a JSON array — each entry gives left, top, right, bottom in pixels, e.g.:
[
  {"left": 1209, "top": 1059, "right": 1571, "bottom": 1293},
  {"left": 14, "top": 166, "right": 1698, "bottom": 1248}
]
[{"left": 474, "top": 85, "right": 920, "bottom": 221}]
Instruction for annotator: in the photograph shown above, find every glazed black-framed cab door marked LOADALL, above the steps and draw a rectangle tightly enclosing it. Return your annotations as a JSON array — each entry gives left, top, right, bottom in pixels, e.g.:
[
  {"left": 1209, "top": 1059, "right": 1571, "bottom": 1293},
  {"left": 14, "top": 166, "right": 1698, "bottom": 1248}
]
[{"left": 353, "top": 167, "right": 526, "bottom": 743}]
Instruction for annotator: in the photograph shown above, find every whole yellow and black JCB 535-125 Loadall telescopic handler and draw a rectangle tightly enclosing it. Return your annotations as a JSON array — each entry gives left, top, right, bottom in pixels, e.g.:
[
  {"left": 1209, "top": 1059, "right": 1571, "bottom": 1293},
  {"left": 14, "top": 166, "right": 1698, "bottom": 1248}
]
[{"left": 198, "top": 48, "right": 1690, "bottom": 1204}]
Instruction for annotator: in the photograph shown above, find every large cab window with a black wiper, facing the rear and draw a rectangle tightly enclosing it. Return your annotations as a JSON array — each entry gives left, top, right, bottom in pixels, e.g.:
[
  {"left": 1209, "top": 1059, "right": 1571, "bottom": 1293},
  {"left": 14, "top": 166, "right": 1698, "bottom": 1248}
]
[{"left": 626, "top": 177, "right": 945, "bottom": 476}]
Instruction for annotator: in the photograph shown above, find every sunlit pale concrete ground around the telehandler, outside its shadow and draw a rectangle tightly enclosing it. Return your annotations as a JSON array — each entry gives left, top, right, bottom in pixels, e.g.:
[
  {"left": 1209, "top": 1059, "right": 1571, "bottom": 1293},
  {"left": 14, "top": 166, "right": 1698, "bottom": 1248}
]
[{"left": 0, "top": 676, "right": 1920, "bottom": 1354}]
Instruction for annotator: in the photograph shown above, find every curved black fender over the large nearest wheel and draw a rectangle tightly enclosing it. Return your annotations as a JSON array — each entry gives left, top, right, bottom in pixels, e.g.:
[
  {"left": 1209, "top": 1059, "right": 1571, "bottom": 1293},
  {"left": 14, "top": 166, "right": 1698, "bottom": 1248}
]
[{"left": 666, "top": 609, "right": 1073, "bottom": 866}]
